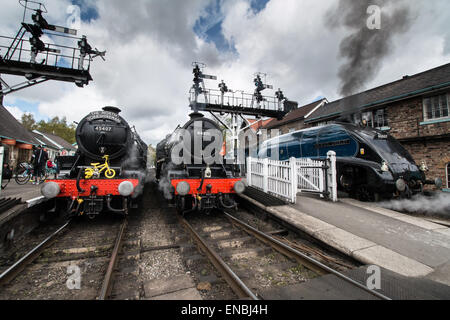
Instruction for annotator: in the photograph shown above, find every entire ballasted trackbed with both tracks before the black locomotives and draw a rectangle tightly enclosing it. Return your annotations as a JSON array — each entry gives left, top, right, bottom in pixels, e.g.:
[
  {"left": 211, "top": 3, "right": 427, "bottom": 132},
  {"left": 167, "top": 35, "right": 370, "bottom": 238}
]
[{"left": 0, "top": 180, "right": 394, "bottom": 300}]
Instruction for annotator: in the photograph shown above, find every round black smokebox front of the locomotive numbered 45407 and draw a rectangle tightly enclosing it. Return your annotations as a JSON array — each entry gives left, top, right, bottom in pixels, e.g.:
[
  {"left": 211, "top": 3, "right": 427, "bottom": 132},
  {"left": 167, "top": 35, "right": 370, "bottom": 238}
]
[{"left": 76, "top": 107, "right": 132, "bottom": 161}]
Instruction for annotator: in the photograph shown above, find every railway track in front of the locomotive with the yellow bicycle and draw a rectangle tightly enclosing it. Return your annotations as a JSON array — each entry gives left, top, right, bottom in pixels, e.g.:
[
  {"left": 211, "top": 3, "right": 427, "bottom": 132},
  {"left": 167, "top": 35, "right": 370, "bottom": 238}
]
[{"left": 0, "top": 218, "right": 134, "bottom": 300}]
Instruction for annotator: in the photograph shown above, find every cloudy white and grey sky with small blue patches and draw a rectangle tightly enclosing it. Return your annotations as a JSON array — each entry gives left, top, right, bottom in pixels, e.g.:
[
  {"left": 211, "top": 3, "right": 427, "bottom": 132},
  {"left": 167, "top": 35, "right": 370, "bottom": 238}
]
[{"left": 0, "top": 0, "right": 450, "bottom": 144}]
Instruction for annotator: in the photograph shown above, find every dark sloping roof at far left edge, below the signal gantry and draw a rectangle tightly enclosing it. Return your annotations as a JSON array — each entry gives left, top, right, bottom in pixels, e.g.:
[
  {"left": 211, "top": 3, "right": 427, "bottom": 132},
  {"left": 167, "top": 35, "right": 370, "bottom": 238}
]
[{"left": 0, "top": 105, "right": 39, "bottom": 145}]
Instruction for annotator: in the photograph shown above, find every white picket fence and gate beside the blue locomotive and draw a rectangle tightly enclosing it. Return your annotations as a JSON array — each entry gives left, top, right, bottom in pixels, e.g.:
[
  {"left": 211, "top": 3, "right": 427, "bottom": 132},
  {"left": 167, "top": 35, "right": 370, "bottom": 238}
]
[{"left": 247, "top": 151, "right": 337, "bottom": 203}]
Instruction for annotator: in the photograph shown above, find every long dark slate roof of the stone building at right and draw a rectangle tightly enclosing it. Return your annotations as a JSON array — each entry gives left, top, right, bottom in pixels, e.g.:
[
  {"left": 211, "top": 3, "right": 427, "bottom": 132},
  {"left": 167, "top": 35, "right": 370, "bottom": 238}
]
[{"left": 305, "top": 63, "right": 450, "bottom": 123}]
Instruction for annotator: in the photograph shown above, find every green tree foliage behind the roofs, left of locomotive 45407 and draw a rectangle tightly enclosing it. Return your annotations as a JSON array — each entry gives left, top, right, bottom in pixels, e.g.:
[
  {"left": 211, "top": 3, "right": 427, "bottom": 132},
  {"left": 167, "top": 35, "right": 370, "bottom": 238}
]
[{"left": 21, "top": 113, "right": 76, "bottom": 143}]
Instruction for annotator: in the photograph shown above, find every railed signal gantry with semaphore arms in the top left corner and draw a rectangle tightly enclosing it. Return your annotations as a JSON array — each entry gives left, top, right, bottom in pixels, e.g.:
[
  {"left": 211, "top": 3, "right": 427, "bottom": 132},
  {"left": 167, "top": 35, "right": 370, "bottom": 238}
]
[{"left": 0, "top": 0, "right": 106, "bottom": 99}]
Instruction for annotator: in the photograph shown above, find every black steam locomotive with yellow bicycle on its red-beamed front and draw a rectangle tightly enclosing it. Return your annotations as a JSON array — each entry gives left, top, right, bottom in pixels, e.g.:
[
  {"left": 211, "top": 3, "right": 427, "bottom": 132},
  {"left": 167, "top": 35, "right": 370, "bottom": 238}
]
[{"left": 41, "top": 107, "right": 147, "bottom": 218}]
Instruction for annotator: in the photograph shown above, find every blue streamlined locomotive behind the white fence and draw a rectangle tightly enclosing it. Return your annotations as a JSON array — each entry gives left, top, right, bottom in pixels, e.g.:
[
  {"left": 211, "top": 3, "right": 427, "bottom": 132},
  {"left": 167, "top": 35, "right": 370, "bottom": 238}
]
[{"left": 259, "top": 123, "right": 442, "bottom": 201}]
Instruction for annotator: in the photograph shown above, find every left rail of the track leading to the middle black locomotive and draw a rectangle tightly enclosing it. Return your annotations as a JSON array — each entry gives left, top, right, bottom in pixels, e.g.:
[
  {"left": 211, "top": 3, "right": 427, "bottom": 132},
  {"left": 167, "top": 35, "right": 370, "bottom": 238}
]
[{"left": 179, "top": 217, "right": 259, "bottom": 300}]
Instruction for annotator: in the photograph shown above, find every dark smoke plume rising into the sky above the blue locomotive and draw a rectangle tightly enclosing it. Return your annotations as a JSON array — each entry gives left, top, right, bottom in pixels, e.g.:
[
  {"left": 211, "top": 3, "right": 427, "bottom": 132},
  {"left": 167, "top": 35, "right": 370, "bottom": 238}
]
[{"left": 326, "top": 0, "right": 412, "bottom": 96}]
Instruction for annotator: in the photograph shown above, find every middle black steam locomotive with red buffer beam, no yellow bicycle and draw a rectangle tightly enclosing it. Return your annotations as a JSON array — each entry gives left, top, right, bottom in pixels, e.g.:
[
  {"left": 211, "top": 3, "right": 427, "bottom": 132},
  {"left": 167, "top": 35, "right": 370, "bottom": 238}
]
[{"left": 156, "top": 113, "right": 245, "bottom": 214}]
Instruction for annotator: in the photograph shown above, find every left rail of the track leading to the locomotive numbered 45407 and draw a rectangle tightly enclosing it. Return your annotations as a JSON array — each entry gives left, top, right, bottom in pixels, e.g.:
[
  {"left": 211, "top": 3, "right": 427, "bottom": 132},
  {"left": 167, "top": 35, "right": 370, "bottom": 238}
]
[{"left": 0, "top": 220, "right": 70, "bottom": 285}]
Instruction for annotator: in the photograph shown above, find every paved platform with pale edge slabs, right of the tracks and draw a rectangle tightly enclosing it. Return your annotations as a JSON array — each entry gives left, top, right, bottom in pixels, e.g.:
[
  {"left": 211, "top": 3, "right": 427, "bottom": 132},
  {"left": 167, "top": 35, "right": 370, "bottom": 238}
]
[{"left": 242, "top": 189, "right": 450, "bottom": 286}]
